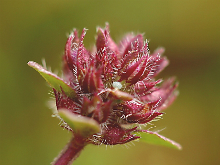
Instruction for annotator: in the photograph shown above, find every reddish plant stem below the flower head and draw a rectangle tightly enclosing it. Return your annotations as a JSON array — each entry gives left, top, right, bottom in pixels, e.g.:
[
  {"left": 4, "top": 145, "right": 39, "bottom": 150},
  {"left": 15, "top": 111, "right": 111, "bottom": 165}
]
[{"left": 52, "top": 136, "right": 86, "bottom": 165}]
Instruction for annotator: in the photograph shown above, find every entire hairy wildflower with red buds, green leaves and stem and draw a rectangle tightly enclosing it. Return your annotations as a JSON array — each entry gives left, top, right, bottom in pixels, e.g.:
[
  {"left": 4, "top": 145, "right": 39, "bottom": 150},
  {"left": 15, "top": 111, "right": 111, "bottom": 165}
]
[{"left": 28, "top": 25, "right": 180, "bottom": 165}]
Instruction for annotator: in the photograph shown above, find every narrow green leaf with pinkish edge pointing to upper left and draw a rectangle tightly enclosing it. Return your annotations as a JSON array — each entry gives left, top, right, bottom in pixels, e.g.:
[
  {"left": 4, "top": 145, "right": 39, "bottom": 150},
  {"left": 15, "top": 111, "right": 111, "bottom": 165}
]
[{"left": 28, "top": 61, "right": 76, "bottom": 99}]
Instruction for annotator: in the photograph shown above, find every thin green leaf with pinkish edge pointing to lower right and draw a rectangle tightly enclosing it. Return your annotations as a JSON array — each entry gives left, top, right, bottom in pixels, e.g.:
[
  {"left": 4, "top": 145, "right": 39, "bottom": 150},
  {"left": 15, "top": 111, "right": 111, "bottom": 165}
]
[{"left": 135, "top": 130, "right": 182, "bottom": 150}]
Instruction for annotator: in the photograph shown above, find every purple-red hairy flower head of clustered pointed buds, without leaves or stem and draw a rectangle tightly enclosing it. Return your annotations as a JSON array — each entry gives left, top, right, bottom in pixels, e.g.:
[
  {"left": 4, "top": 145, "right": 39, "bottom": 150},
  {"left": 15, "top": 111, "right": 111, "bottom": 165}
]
[{"left": 55, "top": 25, "right": 177, "bottom": 144}]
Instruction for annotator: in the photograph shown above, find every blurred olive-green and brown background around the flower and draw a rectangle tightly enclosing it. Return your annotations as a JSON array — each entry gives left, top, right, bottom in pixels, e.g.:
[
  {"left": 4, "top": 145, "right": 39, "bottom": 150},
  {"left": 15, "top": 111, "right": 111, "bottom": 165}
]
[{"left": 0, "top": 0, "right": 220, "bottom": 165}]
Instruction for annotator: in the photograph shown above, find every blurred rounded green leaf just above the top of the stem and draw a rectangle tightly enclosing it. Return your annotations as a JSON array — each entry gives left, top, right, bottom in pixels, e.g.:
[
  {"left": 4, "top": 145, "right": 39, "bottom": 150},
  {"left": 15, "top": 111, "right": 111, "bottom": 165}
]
[{"left": 58, "top": 109, "right": 101, "bottom": 137}]
